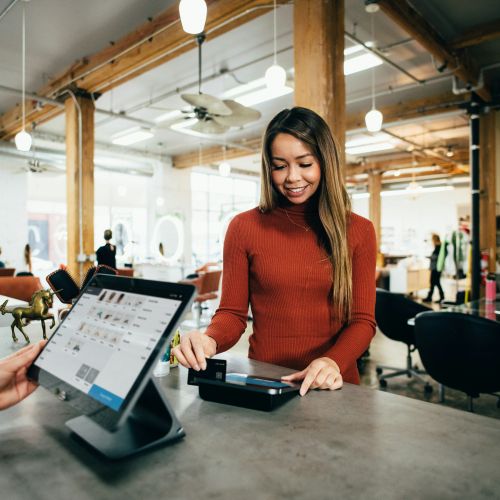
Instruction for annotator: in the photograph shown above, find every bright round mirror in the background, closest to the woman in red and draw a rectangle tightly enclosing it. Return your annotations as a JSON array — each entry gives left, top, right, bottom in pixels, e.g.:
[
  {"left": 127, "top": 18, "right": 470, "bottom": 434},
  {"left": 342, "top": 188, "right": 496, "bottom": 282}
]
[{"left": 151, "top": 215, "right": 184, "bottom": 264}]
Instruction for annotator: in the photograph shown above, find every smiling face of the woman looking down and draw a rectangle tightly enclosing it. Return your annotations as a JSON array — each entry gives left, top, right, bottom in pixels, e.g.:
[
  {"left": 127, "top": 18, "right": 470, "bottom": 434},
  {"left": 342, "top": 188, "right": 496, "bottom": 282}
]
[{"left": 271, "top": 133, "right": 321, "bottom": 205}]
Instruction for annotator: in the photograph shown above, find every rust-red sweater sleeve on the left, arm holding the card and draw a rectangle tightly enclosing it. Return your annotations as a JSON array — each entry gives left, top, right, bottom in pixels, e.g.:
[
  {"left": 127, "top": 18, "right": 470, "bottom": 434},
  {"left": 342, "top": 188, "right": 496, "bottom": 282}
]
[{"left": 206, "top": 216, "right": 249, "bottom": 353}]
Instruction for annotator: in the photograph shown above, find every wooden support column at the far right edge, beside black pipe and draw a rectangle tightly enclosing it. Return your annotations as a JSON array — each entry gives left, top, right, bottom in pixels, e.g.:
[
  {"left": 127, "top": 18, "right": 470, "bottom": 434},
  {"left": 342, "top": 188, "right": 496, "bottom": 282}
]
[{"left": 479, "top": 111, "right": 500, "bottom": 272}]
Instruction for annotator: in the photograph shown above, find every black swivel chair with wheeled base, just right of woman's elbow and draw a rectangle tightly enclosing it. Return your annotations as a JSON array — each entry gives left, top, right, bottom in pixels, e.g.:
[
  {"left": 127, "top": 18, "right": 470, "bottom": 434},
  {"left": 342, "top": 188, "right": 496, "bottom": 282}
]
[{"left": 375, "top": 288, "right": 432, "bottom": 392}]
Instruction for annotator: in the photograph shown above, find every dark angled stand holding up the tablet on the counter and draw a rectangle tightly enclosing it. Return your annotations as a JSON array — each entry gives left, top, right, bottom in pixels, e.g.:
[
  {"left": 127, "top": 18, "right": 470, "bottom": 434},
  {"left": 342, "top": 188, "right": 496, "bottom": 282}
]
[{"left": 66, "top": 379, "right": 184, "bottom": 459}]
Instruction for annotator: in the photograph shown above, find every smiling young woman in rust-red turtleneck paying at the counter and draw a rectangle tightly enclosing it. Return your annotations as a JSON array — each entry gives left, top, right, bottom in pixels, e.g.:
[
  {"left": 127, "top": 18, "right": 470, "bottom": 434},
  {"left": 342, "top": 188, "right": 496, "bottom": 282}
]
[{"left": 174, "top": 107, "right": 376, "bottom": 395}]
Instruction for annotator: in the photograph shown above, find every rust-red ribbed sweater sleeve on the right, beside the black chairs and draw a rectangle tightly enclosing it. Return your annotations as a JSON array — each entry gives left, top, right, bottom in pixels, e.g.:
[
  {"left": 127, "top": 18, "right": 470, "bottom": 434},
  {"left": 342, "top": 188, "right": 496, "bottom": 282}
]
[{"left": 325, "top": 221, "right": 377, "bottom": 373}]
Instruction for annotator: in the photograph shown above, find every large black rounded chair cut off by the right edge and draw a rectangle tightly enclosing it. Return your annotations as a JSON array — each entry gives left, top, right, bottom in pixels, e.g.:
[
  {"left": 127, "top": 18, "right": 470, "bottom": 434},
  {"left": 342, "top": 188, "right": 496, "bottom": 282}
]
[{"left": 415, "top": 311, "right": 500, "bottom": 411}]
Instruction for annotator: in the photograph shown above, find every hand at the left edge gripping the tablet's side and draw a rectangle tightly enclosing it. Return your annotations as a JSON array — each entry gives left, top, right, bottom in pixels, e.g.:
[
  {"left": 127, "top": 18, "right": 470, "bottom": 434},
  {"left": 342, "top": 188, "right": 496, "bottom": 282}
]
[{"left": 0, "top": 340, "right": 47, "bottom": 410}]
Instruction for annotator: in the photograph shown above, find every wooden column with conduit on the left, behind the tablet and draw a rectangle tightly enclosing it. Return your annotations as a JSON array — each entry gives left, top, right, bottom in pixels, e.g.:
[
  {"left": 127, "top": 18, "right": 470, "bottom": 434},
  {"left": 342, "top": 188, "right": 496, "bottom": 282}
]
[{"left": 65, "top": 96, "right": 95, "bottom": 280}]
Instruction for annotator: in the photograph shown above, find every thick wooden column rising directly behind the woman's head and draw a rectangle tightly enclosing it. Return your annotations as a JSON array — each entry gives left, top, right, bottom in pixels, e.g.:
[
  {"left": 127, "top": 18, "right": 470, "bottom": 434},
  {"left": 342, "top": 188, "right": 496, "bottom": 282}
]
[{"left": 293, "top": 0, "right": 346, "bottom": 168}]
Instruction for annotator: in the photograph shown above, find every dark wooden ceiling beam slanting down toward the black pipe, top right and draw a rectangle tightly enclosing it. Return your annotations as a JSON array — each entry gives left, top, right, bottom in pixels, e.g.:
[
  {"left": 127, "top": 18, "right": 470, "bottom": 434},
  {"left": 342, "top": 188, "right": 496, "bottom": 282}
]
[{"left": 378, "top": 0, "right": 491, "bottom": 101}]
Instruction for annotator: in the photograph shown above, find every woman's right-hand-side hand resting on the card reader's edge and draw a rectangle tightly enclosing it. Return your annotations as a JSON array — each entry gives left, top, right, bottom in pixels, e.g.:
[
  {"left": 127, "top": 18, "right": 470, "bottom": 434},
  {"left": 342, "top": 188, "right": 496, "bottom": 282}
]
[{"left": 281, "top": 357, "right": 343, "bottom": 396}]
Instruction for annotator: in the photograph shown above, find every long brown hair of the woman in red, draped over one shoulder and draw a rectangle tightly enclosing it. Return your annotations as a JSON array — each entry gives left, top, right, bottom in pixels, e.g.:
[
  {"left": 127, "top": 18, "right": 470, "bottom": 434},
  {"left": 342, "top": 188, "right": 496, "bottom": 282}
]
[{"left": 259, "top": 107, "right": 352, "bottom": 321}]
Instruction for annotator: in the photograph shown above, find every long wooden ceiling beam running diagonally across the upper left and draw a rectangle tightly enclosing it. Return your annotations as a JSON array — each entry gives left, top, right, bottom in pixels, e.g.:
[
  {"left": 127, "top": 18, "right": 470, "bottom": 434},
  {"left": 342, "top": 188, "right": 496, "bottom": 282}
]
[{"left": 0, "top": 0, "right": 287, "bottom": 139}]
